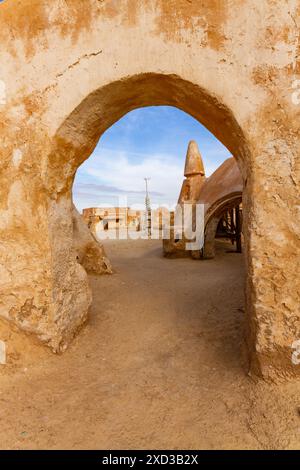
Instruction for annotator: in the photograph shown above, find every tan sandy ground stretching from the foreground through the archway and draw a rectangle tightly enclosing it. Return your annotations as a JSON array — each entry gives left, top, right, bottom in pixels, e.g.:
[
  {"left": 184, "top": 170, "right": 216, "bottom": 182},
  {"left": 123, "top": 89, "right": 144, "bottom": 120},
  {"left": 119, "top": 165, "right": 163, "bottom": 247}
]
[{"left": 0, "top": 241, "right": 300, "bottom": 449}]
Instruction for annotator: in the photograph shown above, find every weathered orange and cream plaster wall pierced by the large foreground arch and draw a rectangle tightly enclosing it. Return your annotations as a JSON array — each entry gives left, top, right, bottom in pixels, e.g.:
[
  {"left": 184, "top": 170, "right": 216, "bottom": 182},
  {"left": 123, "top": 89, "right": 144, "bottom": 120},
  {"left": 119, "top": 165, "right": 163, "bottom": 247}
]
[{"left": 0, "top": 0, "right": 300, "bottom": 376}]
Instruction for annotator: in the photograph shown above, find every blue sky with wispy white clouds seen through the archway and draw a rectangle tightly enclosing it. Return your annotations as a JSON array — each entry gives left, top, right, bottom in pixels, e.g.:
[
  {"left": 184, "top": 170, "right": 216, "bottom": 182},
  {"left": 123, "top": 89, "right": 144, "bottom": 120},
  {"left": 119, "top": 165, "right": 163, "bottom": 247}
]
[{"left": 73, "top": 106, "right": 230, "bottom": 211}]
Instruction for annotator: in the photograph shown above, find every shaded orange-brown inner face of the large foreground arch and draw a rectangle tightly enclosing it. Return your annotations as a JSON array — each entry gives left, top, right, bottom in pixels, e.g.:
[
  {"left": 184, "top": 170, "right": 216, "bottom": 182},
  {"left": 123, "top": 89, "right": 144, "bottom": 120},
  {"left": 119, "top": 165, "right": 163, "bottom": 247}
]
[{"left": 41, "top": 73, "right": 249, "bottom": 348}]
